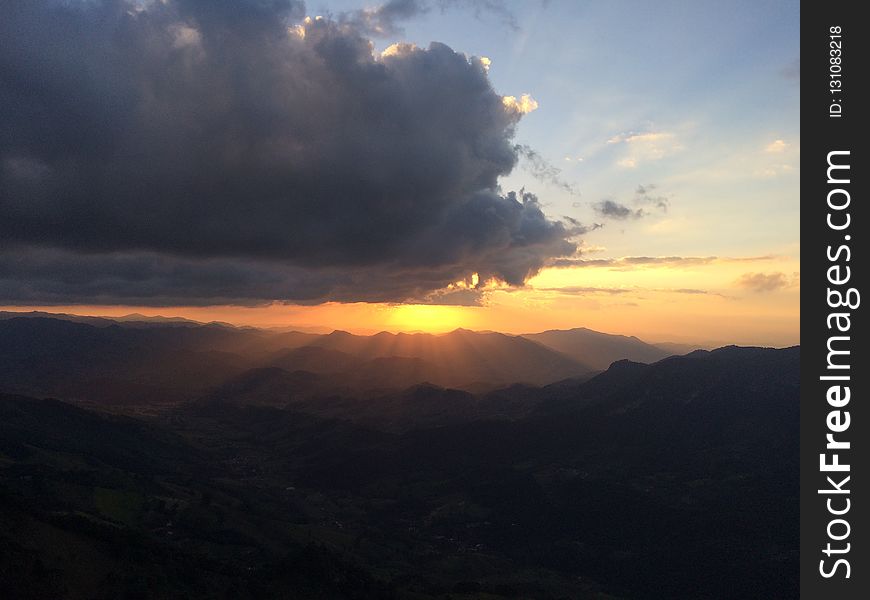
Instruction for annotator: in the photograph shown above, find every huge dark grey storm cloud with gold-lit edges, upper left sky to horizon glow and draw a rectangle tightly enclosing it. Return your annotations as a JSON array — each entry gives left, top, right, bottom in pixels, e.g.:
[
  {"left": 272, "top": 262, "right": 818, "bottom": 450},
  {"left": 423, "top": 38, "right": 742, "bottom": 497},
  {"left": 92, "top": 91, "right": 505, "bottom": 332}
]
[{"left": 0, "top": 0, "right": 584, "bottom": 304}]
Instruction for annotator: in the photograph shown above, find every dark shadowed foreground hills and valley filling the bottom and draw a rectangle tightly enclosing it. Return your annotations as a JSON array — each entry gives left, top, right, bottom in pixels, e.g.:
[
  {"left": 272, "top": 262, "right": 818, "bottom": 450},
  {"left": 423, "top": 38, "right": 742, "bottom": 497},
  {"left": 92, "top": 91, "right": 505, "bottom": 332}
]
[{"left": 0, "top": 347, "right": 800, "bottom": 600}]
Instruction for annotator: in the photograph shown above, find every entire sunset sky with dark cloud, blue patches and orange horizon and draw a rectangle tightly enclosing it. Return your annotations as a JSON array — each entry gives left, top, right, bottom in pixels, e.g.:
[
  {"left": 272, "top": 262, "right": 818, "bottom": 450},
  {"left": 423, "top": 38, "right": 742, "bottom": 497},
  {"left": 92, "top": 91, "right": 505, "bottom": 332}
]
[{"left": 0, "top": 0, "right": 800, "bottom": 346}]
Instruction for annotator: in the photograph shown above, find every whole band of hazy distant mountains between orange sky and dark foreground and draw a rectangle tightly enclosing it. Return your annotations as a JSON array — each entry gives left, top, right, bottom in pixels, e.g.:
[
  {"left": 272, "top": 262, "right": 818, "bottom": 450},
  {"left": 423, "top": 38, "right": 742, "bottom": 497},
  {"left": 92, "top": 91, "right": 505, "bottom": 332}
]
[{"left": 0, "top": 313, "right": 788, "bottom": 427}]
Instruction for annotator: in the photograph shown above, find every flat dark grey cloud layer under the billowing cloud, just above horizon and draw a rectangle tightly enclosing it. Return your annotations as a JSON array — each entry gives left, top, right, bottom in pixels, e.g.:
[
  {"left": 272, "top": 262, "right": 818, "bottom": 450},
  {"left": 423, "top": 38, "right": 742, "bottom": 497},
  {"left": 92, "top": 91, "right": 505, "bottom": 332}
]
[{"left": 0, "top": 249, "right": 500, "bottom": 306}]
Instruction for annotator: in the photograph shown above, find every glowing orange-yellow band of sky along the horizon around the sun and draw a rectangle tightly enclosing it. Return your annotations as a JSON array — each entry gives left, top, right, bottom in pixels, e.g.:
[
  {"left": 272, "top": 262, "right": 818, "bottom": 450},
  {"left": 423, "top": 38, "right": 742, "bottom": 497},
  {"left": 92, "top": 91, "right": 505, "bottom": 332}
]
[{"left": 3, "top": 256, "right": 800, "bottom": 346}]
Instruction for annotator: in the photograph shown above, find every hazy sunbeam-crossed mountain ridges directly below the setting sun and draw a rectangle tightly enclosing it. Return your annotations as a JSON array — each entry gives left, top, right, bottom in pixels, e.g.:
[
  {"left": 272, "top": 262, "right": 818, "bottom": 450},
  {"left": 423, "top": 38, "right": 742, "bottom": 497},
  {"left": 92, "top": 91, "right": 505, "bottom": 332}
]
[{"left": 0, "top": 314, "right": 590, "bottom": 410}]
